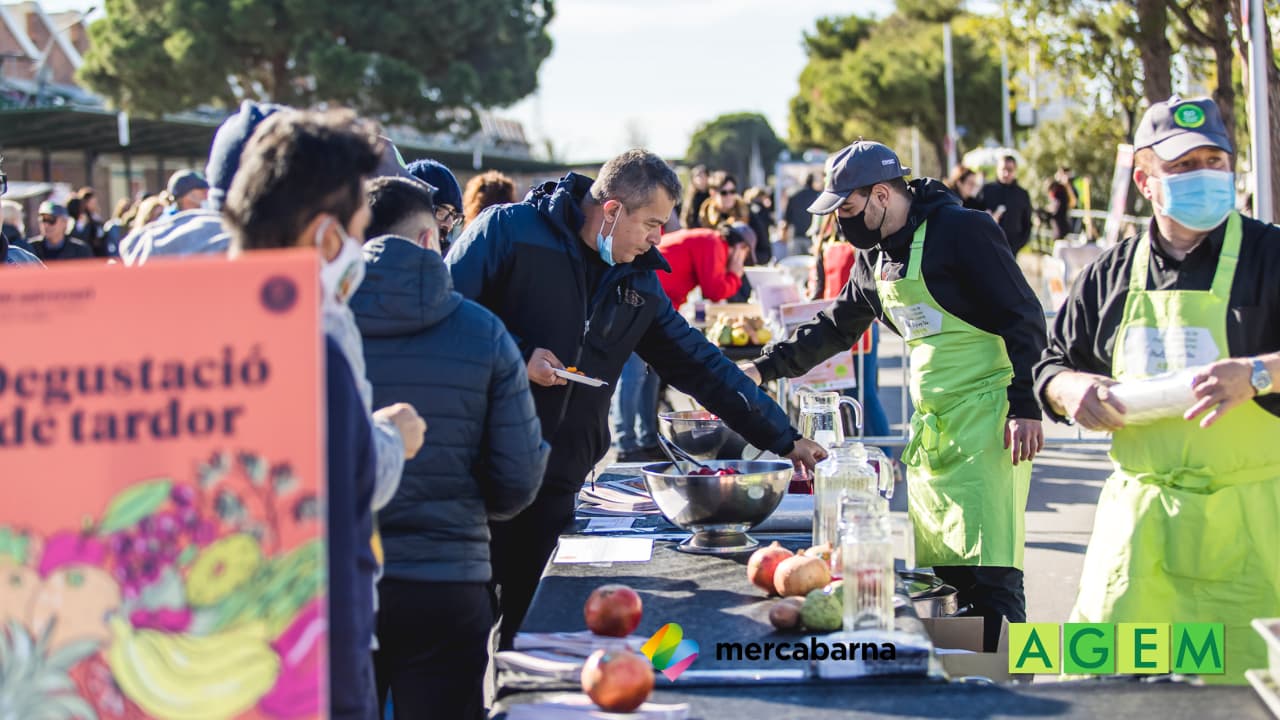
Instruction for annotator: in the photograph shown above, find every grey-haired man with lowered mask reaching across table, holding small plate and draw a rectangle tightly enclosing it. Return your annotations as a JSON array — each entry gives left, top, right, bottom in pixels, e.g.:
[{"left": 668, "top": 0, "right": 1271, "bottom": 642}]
[{"left": 448, "top": 150, "right": 826, "bottom": 647}]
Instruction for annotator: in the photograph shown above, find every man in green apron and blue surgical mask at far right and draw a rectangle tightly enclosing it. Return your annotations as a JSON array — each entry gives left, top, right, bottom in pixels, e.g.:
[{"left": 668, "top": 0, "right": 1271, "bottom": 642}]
[{"left": 1036, "top": 97, "right": 1280, "bottom": 683}]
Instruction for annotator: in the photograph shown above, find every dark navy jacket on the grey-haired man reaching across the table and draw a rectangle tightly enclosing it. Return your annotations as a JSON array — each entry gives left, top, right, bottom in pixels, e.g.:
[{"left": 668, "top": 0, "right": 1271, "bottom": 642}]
[{"left": 448, "top": 173, "right": 800, "bottom": 492}]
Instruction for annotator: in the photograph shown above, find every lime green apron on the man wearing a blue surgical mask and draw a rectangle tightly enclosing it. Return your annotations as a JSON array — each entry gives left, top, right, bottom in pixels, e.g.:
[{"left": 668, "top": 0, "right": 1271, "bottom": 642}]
[{"left": 1071, "top": 213, "right": 1280, "bottom": 683}]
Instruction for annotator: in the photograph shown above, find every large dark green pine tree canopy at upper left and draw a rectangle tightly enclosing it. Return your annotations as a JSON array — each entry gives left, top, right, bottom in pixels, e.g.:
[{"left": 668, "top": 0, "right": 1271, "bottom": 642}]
[{"left": 81, "top": 0, "right": 553, "bottom": 129}]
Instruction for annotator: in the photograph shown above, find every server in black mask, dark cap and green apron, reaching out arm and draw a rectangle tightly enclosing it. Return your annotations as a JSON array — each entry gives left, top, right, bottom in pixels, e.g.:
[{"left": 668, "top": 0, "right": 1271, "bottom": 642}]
[{"left": 744, "top": 141, "right": 1046, "bottom": 650}]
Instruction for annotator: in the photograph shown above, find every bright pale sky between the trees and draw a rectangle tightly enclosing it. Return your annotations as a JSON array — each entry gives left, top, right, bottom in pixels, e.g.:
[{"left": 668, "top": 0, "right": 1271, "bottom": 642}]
[{"left": 35, "top": 0, "right": 993, "bottom": 161}]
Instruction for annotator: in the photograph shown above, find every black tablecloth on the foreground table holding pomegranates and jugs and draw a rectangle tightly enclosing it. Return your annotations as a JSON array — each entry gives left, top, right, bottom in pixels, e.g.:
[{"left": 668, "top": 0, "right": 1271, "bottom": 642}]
[{"left": 483, "top": 468, "right": 1268, "bottom": 720}]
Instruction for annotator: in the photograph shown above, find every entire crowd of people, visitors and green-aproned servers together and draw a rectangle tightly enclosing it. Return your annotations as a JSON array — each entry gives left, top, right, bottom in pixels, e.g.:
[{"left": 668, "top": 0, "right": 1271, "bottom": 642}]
[{"left": 0, "top": 89, "right": 1280, "bottom": 719}]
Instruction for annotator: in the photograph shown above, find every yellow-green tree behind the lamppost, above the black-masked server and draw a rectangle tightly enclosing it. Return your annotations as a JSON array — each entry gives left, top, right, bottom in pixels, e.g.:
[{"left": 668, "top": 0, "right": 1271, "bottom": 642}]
[{"left": 790, "top": 4, "right": 1002, "bottom": 172}]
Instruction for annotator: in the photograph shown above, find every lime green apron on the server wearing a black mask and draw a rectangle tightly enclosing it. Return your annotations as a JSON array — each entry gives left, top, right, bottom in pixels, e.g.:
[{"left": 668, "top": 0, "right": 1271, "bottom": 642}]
[{"left": 876, "top": 223, "right": 1032, "bottom": 569}]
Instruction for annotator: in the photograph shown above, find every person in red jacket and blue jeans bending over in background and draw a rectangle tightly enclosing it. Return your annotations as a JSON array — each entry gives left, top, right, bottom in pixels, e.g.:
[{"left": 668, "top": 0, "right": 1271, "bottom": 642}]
[{"left": 609, "top": 223, "right": 755, "bottom": 462}]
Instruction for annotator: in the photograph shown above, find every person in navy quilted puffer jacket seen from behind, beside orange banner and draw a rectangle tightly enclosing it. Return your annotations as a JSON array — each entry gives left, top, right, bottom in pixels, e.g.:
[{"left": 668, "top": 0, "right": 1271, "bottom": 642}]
[{"left": 351, "top": 178, "right": 550, "bottom": 720}]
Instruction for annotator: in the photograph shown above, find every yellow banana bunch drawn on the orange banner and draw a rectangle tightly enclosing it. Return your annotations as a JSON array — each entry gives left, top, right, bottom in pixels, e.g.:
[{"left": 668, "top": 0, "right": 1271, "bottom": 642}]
[{"left": 106, "top": 616, "right": 280, "bottom": 720}]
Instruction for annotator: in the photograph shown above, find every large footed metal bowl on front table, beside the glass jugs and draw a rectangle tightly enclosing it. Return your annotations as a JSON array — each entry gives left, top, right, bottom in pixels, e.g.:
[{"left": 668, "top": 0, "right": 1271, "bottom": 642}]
[{"left": 640, "top": 460, "right": 792, "bottom": 555}]
